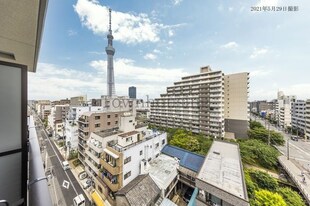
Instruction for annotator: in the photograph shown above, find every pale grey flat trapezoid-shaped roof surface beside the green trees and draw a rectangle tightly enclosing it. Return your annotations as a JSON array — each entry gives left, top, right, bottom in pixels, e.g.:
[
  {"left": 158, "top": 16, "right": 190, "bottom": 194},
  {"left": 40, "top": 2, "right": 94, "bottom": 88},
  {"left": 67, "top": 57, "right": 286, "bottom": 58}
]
[{"left": 197, "top": 141, "right": 247, "bottom": 200}]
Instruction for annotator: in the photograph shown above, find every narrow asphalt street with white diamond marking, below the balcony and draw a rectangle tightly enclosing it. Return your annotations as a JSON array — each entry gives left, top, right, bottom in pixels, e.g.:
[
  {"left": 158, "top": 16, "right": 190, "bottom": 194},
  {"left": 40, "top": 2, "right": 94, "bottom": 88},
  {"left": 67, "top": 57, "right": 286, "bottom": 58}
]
[{"left": 35, "top": 116, "right": 90, "bottom": 206}]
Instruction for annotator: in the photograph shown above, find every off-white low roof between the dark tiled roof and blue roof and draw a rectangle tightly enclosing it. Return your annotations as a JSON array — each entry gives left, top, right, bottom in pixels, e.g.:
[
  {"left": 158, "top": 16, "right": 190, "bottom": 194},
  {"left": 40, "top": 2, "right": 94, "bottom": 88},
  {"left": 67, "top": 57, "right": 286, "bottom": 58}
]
[{"left": 145, "top": 154, "right": 179, "bottom": 189}]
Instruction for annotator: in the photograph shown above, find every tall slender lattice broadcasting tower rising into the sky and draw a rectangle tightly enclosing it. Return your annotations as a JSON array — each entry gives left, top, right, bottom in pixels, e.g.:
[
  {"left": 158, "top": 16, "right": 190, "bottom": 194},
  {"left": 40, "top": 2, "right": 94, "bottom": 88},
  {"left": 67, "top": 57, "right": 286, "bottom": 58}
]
[{"left": 105, "top": 9, "right": 115, "bottom": 97}]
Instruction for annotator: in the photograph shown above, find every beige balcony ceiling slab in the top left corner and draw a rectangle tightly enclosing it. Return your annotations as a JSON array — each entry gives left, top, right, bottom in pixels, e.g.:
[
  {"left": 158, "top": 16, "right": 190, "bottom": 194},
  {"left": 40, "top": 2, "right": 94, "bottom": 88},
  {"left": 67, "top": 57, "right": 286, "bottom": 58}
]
[{"left": 0, "top": 0, "right": 48, "bottom": 72}]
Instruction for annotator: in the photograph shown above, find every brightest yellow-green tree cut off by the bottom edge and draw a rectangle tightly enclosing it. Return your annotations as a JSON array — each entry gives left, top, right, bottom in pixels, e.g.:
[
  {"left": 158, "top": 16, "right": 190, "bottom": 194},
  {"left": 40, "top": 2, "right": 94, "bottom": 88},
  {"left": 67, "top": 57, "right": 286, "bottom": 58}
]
[{"left": 250, "top": 190, "right": 286, "bottom": 206}]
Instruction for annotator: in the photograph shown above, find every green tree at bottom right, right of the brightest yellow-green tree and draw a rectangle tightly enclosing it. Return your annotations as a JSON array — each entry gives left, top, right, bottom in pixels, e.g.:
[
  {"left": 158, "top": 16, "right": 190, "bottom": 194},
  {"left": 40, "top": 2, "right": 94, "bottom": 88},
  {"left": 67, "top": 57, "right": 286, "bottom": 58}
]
[{"left": 278, "top": 187, "right": 306, "bottom": 206}]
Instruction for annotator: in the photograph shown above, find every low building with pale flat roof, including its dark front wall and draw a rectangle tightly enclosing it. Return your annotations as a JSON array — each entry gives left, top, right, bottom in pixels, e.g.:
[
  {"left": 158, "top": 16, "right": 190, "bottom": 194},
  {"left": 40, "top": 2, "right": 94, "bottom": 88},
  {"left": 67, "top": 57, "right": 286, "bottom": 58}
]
[{"left": 196, "top": 141, "right": 249, "bottom": 206}]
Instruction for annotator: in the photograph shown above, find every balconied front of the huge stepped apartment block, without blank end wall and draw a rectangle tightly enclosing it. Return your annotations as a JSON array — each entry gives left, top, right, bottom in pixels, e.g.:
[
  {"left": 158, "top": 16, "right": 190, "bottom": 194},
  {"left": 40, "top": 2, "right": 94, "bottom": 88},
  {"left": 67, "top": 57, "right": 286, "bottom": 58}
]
[{"left": 150, "top": 66, "right": 224, "bottom": 137}]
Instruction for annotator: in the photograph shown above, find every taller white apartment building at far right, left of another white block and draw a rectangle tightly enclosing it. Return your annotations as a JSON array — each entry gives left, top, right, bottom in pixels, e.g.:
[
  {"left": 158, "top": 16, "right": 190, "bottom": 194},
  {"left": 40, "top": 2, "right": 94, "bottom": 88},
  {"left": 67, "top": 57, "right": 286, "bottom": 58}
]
[{"left": 275, "top": 91, "right": 296, "bottom": 128}]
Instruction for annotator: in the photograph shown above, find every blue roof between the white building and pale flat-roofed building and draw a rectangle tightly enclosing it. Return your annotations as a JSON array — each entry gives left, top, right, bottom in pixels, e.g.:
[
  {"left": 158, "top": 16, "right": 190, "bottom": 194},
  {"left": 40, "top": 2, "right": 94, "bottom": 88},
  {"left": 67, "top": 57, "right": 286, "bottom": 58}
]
[{"left": 161, "top": 145, "right": 205, "bottom": 173}]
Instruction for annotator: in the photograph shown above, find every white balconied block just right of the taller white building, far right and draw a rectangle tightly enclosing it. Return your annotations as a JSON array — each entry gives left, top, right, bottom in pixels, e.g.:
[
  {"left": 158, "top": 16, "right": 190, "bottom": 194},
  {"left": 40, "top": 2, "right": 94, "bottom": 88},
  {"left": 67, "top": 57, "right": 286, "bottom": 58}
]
[{"left": 291, "top": 100, "right": 306, "bottom": 134}]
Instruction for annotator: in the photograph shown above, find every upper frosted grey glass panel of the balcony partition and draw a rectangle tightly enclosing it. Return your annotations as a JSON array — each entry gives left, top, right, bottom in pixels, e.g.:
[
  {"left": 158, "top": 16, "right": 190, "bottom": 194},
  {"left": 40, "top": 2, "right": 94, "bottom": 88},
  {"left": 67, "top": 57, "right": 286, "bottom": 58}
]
[{"left": 0, "top": 65, "right": 22, "bottom": 152}]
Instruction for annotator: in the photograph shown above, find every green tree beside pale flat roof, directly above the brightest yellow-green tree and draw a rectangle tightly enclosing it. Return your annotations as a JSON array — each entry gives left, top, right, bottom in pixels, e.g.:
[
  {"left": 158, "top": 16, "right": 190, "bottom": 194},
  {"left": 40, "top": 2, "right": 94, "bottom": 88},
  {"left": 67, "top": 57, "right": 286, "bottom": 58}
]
[{"left": 249, "top": 170, "right": 279, "bottom": 191}]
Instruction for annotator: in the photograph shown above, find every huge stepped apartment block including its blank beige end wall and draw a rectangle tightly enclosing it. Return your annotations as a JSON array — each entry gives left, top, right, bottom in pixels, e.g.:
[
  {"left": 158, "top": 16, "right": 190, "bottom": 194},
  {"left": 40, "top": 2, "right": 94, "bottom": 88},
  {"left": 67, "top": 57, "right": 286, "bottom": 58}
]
[{"left": 150, "top": 66, "right": 248, "bottom": 137}]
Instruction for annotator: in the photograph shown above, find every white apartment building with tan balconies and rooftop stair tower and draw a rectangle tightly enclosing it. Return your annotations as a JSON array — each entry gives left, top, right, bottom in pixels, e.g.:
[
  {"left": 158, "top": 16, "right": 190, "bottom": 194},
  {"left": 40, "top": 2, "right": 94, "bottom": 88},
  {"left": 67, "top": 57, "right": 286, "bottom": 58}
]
[{"left": 84, "top": 113, "right": 167, "bottom": 204}]
